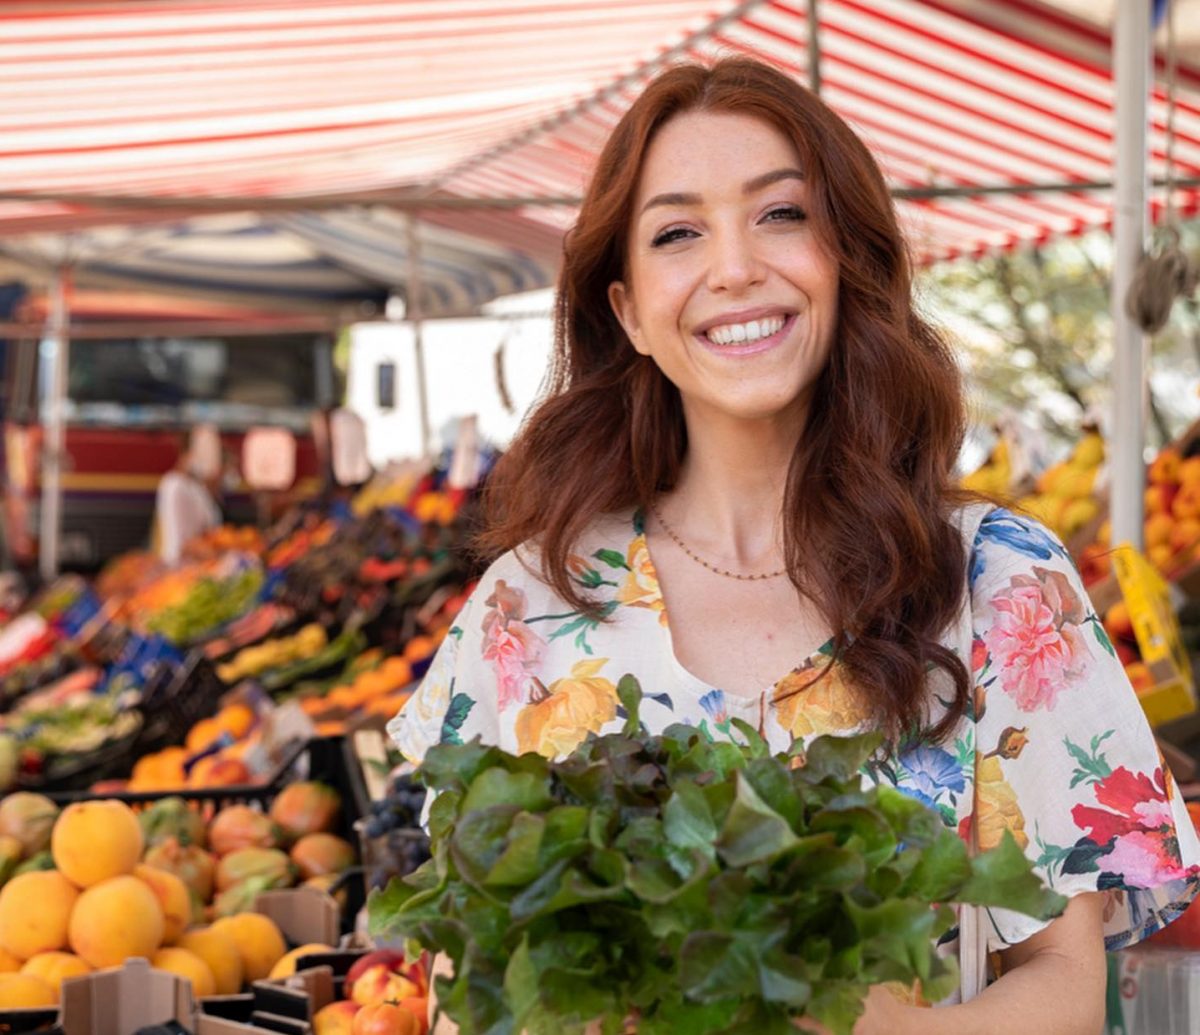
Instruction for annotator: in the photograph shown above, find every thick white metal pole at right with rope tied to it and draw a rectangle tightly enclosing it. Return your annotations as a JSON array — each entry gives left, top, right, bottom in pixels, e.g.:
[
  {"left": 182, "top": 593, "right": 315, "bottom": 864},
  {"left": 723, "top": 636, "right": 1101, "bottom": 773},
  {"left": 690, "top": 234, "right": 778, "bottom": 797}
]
[{"left": 1109, "top": 0, "right": 1151, "bottom": 550}]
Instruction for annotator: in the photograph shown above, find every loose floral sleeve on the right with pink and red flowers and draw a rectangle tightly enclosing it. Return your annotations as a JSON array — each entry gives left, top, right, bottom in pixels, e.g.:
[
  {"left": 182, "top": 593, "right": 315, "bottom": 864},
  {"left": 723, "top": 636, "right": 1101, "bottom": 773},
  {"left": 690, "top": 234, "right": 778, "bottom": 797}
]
[{"left": 970, "top": 509, "right": 1200, "bottom": 951}]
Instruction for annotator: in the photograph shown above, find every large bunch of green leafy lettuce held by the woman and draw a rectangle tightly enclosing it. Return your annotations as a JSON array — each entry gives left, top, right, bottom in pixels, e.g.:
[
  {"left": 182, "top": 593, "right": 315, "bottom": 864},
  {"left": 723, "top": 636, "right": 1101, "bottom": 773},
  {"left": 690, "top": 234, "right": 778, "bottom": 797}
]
[{"left": 370, "top": 676, "right": 1066, "bottom": 1035}]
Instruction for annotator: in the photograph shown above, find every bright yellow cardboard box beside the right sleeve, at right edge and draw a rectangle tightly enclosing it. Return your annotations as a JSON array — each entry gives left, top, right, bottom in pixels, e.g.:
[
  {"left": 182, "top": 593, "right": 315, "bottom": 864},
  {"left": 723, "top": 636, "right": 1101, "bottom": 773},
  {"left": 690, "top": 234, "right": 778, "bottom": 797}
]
[{"left": 1112, "top": 543, "right": 1195, "bottom": 726}]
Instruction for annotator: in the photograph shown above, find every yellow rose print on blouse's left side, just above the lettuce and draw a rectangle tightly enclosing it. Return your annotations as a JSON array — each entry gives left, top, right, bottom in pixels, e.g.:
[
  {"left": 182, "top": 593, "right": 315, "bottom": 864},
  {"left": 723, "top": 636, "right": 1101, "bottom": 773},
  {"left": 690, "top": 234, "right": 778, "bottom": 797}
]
[{"left": 516, "top": 658, "right": 618, "bottom": 758}]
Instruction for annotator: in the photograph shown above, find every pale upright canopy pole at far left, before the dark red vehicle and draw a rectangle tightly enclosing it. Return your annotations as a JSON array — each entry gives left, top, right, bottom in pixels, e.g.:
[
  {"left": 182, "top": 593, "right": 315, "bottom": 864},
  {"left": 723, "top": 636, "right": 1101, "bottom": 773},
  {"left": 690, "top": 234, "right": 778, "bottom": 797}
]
[{"left": 37, "top": 267, "right": 71, "bottom": 582}]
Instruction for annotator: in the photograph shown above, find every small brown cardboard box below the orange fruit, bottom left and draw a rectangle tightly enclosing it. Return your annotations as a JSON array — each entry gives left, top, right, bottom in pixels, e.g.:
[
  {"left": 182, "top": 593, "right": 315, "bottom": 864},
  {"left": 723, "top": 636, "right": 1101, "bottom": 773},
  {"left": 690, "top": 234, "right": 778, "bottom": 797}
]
[{"left": 61, "top": 958, "right": 196, "bottom": 1035}]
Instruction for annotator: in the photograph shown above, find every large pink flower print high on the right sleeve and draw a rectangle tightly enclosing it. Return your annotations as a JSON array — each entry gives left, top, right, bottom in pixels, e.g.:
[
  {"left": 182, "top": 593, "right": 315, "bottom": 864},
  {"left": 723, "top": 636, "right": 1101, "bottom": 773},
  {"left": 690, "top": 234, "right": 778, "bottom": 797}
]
[{"left": 972, "top": 569, "right": 1091, "bottom": 712}]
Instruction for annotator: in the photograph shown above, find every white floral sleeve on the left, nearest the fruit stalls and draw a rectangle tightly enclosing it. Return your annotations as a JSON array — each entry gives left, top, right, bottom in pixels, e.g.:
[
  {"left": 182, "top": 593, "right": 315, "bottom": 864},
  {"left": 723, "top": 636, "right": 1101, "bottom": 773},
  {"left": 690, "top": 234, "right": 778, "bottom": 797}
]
[{"left": 388, "top": 584, "right": 498, "bottom": 765}]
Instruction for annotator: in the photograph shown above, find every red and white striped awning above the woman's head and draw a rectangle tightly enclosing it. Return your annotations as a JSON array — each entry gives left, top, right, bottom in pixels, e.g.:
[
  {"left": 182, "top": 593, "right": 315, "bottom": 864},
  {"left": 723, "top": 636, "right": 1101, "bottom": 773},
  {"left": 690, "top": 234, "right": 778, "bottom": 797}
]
[{"left": 0, "top": 0, "right": 1200, "bottom": 303}]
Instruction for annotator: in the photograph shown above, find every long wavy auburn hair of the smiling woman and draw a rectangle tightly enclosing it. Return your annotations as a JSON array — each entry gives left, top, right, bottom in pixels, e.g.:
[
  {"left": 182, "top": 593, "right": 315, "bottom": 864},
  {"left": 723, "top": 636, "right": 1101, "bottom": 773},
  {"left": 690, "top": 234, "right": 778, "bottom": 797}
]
[{"left": 480, "top": 58, "right": 972, "bottom": 738}]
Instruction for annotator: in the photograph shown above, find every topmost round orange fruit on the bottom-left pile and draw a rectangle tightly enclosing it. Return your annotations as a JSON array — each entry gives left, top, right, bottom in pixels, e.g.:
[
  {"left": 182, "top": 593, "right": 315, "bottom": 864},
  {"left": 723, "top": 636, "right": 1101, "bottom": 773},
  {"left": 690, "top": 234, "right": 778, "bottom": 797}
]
[{"left": 50, "top": 800, "right": 145, "bottom": 887}]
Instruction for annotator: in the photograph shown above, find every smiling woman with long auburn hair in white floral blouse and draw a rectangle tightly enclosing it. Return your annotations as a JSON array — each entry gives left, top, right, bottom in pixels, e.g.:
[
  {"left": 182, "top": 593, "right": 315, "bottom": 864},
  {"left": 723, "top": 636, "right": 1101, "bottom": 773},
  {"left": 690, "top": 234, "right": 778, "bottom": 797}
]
[{"left": 390, "top": 59, "right": 1200, "bottom": 1035}]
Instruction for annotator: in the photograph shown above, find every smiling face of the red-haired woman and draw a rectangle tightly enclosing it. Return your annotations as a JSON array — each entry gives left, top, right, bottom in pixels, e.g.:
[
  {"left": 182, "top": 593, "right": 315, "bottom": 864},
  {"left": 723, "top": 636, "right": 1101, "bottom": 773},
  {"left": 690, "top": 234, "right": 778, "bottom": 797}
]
[{"left": 608, "top": 112, "right": 838, "bottom": 430}]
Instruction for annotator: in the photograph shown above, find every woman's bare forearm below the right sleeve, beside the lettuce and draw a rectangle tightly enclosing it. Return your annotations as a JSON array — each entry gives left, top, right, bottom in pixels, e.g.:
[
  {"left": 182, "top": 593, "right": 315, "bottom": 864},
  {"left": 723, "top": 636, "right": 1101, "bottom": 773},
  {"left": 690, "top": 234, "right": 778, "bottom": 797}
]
[{"left": 835, "top": 892, "right": 1106, "bottom": 1035}]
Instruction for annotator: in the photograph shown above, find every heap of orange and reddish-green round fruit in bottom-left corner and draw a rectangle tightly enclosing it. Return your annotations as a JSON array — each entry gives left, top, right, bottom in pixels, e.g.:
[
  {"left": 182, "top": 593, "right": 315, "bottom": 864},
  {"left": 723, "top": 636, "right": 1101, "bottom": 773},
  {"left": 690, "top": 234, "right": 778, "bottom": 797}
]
[{"left": 0, "top": 782, "right": 355, "bottom": 1006}]
